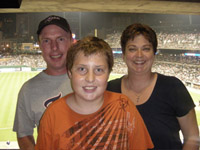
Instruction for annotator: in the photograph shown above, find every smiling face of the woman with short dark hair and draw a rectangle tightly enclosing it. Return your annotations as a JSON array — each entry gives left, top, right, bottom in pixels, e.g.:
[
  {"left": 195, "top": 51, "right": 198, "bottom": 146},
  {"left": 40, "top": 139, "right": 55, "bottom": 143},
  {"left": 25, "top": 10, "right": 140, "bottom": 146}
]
[{"left": 123, "top": 34, "right": 155, "bottom": 75}]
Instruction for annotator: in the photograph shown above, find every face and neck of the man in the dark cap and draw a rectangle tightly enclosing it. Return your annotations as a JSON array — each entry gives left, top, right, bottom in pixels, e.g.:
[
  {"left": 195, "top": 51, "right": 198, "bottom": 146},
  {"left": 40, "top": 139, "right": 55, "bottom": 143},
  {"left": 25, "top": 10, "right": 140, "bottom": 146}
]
[{"left": 39, "top": 25, "right": 72, "bottom": 75}]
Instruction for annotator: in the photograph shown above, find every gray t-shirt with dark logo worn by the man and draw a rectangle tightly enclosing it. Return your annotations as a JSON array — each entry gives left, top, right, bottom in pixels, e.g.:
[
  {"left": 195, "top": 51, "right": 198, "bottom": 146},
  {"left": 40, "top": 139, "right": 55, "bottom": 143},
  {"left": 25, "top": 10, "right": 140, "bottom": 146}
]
[{"left": 13, "top": 72, "right": 72, "bottom": 137}]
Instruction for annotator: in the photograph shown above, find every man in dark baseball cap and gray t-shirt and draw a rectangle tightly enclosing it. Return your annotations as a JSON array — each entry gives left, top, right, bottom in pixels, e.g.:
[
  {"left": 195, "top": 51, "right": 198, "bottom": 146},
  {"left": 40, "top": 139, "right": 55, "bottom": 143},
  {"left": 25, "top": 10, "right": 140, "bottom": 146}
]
[{"left": 13, "top": 16, "right": 72, "bottom": 150}]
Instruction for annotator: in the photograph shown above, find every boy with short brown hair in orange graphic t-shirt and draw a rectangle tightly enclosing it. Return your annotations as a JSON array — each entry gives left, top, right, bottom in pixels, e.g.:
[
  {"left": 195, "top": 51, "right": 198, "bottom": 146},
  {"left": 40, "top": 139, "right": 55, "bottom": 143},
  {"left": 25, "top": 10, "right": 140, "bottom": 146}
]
[{"left": 36, "top": 37, "right": 153, "bottom": 150}]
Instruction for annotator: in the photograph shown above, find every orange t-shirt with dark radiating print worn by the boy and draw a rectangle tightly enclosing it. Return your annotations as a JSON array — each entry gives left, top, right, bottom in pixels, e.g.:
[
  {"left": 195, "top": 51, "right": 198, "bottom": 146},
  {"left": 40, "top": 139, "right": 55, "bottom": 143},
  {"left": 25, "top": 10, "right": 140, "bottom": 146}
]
[{"left": 35, "top": 91, "right": 153, "bottom": 150}]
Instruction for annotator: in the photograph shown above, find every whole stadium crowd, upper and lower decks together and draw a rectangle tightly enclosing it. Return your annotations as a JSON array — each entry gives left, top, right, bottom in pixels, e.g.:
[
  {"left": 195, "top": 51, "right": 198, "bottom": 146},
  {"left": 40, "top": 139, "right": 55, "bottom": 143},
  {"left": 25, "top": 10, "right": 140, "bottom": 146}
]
[{"left": 0, "top": 32, "right": 200, "bottom": 88}]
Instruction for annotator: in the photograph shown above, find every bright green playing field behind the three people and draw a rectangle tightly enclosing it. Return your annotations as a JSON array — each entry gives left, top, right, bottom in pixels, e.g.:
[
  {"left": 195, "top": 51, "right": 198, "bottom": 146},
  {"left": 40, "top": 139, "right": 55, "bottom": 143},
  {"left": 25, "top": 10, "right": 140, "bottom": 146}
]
[{"left": 0, "top": 72, "right": 200, "bottom": 141}]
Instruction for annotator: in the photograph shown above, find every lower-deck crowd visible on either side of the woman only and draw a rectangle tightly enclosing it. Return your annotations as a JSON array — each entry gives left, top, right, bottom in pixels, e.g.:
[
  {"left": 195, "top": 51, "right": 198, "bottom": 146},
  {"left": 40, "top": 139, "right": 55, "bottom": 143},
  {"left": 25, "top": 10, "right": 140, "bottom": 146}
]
[{"left": 113, "top": 54, "right": 200, "bottom": 88}]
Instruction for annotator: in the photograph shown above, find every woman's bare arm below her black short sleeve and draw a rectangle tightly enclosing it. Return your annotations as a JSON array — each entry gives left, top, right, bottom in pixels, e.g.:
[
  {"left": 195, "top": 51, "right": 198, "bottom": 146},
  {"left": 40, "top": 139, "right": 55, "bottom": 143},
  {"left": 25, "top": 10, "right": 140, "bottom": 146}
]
[{"left": 178, "top": 109, "right": 200, "bottom": 150}]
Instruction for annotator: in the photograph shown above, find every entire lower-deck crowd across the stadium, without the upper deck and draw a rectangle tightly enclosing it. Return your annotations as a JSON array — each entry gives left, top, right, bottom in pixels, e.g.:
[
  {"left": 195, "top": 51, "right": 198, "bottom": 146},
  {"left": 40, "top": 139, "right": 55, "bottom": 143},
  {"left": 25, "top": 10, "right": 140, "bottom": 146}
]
[{"left": 0, "top": 54, "right": 200, "bottom": 89}]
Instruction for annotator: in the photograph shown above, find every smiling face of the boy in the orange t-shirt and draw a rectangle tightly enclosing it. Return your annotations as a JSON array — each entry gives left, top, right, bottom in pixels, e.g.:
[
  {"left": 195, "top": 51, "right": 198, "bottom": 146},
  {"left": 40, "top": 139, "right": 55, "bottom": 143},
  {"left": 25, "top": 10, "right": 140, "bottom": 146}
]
[{"left": 69, "top": 52, "right": 109, "bottom": 101}]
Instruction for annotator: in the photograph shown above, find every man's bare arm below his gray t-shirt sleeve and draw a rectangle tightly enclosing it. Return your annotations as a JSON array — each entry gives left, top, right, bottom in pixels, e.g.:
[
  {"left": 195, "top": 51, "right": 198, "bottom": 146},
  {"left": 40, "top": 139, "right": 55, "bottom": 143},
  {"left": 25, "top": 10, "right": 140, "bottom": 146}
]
[{"left": 17, "top": 135, "right": 35, "bottom": 150}]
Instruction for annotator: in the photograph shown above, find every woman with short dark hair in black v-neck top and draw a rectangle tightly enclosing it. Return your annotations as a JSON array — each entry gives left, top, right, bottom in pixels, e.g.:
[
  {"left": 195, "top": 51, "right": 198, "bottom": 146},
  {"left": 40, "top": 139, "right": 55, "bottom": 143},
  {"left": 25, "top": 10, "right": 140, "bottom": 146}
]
[{"left": 107, "top": 24, "right": 199, "bottom": 150}]
